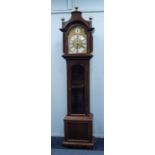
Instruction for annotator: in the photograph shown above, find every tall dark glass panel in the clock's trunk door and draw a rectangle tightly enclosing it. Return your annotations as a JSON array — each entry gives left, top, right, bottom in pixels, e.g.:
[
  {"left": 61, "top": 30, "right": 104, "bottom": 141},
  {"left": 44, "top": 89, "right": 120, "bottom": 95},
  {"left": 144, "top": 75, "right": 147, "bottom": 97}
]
[{"left": 71, "top": 65, "right": 85, "bottom": 114}]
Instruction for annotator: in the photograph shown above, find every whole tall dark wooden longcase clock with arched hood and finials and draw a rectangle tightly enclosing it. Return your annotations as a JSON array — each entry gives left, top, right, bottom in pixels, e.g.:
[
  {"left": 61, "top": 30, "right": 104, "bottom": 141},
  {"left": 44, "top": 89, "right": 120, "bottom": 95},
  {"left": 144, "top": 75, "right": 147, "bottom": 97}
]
[{"left": 60, "top": 7, "right": 94, "bottom": 148}]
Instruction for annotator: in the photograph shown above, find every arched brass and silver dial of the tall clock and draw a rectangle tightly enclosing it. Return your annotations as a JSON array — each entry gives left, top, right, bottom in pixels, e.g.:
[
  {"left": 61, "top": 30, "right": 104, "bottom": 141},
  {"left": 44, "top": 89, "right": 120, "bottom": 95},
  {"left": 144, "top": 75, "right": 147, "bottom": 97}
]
[{"left": 68, "top": 26, "right": 87, "bottom": 54}]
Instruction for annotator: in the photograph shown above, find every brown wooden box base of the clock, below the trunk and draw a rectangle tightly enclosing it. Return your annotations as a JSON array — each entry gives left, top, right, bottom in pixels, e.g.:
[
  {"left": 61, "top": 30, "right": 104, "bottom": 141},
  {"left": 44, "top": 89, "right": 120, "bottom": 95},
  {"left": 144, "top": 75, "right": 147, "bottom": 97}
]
[{"left": 63, "top": 114, "right": 94, "bottom": 148}]
